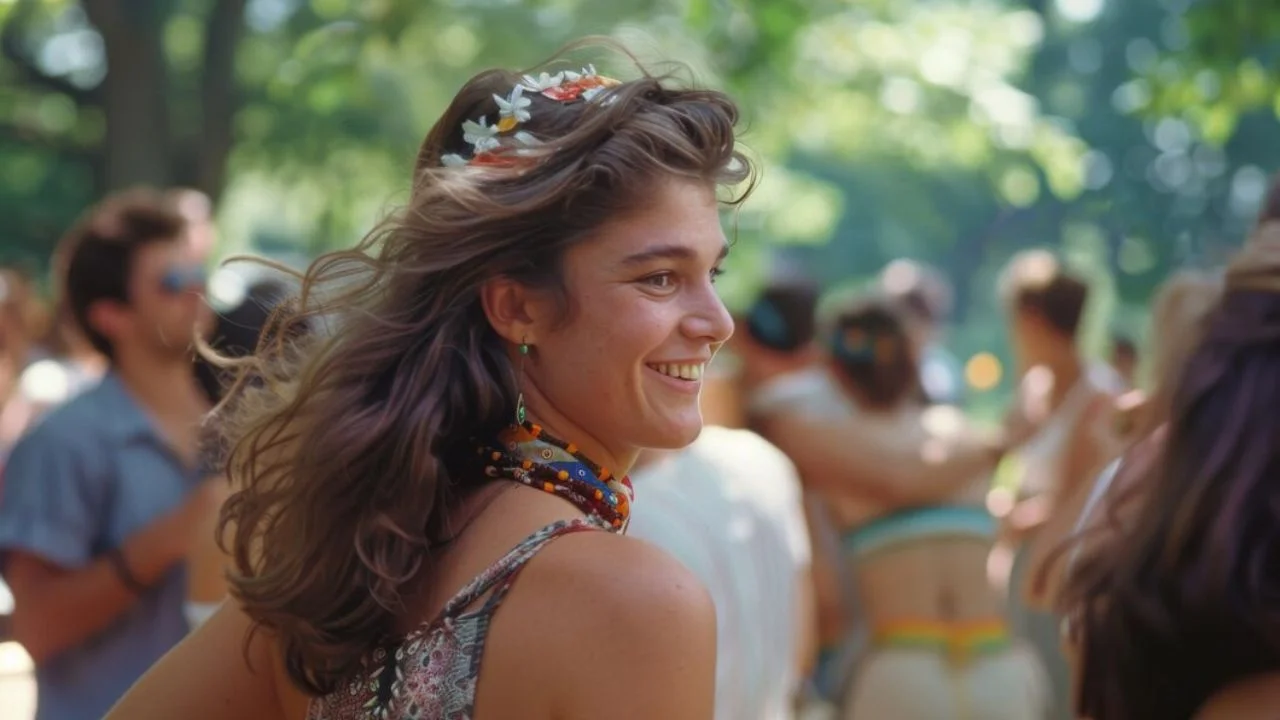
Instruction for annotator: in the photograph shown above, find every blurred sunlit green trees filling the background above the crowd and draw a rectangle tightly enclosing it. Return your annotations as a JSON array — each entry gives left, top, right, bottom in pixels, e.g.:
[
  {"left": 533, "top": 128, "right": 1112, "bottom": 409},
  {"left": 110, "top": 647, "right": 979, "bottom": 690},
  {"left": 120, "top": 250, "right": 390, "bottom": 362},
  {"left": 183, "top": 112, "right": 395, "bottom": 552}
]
[{"left": 0, "top": 0, "right": 1280, "bottom": 417}]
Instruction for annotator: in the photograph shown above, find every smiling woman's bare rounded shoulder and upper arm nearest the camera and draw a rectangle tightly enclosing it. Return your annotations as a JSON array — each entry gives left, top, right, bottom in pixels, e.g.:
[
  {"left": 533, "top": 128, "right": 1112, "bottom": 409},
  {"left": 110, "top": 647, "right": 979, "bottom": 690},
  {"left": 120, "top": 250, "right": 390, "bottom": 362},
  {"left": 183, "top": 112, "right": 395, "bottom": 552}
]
[{"left": 496, "top": 533, "right": 721, "bottom": 720}]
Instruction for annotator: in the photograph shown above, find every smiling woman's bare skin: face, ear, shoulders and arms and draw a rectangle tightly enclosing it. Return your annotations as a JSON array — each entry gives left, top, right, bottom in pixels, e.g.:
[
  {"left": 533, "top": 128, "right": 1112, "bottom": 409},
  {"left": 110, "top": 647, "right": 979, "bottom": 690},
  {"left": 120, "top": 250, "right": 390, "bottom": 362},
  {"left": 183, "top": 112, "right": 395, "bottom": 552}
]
[{"left": 108, "top": 182, "right": 732, "bottom": 720}]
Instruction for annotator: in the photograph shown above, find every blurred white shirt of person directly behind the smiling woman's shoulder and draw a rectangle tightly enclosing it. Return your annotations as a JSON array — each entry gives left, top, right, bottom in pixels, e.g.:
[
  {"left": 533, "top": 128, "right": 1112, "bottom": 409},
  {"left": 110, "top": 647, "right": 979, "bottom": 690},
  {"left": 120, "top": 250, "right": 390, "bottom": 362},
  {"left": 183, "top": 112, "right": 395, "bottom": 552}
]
[{"left": 627, "top": 366, "right": 815, "bottom": 720}]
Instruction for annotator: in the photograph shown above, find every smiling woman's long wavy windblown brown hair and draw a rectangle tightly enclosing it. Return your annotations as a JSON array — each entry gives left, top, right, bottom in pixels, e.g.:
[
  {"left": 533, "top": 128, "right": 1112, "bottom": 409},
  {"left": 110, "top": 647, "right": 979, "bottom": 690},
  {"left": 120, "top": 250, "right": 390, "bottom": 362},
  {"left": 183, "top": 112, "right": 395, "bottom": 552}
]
[{"left": 209, "top": 40, "right": 751, "bottom": 694}]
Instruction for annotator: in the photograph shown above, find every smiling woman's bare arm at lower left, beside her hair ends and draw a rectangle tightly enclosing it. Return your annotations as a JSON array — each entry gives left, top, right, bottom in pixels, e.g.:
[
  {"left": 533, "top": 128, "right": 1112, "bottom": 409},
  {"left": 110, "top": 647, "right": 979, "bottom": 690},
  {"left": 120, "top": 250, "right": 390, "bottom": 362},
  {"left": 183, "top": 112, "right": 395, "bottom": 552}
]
[{"left": 106, "top": 602, "right": 306, "bottom": 720}]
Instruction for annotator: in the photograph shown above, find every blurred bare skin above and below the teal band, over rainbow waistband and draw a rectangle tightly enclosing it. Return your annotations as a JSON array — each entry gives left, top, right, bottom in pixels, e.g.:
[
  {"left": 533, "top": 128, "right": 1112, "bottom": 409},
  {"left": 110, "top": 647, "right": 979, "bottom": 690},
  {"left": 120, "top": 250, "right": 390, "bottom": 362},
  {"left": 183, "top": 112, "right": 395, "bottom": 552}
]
[{"left": 747, "top": 340, "right": 1025, "bottom": 645}]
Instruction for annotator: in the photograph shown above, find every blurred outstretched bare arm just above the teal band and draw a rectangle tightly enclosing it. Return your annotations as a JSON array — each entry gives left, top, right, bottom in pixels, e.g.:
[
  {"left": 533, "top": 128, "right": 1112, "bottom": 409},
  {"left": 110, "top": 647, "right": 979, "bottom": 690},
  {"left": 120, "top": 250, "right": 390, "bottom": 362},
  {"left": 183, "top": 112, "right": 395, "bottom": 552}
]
[{"left": 762, "top": 411, "right": 1009, "bottom": 506}]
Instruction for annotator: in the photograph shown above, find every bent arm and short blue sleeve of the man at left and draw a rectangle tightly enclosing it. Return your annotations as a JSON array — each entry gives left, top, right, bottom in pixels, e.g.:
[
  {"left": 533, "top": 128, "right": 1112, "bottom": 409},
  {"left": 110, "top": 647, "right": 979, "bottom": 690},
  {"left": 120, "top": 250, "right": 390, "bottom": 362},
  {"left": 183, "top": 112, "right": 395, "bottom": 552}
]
[{"left": 0, "top": 423, "right": 221, "bottom": 665}]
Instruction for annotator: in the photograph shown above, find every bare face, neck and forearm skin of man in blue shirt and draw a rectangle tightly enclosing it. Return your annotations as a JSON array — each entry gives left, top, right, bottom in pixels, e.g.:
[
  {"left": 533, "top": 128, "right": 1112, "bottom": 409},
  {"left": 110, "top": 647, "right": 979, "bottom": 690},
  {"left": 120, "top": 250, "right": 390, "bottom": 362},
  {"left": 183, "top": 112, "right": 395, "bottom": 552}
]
[{"left": 4, "top": 240, "right": 220, "bottom": 665}]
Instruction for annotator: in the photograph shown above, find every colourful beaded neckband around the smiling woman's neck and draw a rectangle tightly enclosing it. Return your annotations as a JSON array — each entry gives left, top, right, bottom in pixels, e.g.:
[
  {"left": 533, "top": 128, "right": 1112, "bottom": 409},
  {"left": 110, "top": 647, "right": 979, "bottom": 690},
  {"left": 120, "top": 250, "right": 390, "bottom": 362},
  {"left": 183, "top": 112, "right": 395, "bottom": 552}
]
[{"left": 480, "top": 423, "right": 635, "bottom": 533}]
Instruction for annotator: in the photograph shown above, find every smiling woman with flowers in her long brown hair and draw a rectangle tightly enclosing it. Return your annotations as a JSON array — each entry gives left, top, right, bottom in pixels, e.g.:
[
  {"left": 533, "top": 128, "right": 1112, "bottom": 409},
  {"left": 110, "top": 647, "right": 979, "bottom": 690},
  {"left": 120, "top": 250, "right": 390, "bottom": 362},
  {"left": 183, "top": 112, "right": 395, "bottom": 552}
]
[{"left": 111, "top": 37, "right": 750, "bottom": 720}]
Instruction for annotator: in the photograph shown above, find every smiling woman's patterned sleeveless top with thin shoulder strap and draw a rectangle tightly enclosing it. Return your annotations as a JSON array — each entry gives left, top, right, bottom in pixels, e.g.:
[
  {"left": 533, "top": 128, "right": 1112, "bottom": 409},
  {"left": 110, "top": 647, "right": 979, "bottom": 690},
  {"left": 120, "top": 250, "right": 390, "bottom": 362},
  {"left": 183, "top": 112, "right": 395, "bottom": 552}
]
[{"left": 307, "top": 516, "right": 612, "bottom": 720}]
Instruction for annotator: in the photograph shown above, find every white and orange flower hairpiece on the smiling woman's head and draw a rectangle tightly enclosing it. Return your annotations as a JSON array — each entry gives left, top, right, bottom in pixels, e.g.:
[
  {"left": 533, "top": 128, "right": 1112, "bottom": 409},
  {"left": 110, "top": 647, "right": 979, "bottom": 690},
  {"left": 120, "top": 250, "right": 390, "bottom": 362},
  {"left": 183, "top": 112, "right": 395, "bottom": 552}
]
[{"left": 440, "top": 65, "right": 621, "bottom": 168}]
